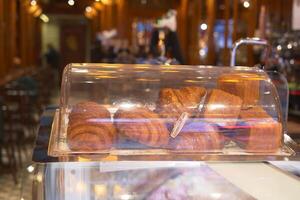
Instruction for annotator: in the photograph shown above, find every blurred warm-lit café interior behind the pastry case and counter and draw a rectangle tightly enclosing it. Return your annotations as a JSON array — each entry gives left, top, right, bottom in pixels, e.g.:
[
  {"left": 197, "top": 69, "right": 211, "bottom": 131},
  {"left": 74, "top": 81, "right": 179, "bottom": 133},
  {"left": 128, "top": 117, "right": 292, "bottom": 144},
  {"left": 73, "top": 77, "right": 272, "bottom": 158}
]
[{"left": 0, "top": 0, "right": 300, "bottom": 199}]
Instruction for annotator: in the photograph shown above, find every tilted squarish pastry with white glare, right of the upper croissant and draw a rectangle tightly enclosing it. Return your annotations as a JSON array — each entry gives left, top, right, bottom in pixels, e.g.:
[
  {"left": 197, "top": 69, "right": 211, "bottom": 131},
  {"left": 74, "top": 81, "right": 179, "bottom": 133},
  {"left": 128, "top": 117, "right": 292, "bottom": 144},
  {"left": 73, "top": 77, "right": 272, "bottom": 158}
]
[{"left": 203, "top": 89, "right": 242, "bottom": 126}]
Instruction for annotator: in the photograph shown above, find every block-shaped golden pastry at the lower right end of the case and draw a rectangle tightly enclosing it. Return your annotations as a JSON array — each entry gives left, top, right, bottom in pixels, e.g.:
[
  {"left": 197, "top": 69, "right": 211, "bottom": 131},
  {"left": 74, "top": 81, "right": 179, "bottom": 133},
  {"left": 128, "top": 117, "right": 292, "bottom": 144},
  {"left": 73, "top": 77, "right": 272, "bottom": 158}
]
[{"left": 234, "top": 106, "right": 282, "bottom": 152}]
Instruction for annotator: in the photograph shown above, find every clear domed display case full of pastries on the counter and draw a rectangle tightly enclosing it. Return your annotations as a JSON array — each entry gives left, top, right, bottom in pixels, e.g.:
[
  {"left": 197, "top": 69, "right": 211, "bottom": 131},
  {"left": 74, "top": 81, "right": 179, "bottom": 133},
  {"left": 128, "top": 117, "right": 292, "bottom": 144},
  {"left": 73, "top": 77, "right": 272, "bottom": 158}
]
[{"left": 48, "top": 64, "right": 293, "bottom": 160}]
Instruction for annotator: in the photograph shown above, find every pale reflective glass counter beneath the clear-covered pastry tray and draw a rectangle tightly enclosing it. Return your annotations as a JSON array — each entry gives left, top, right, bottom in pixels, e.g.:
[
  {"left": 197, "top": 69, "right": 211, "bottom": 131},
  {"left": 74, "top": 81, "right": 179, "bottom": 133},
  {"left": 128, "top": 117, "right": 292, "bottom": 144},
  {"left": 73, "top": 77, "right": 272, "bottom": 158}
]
[{"left": 27, "top": 161, "right": 300, "bottom": 200}]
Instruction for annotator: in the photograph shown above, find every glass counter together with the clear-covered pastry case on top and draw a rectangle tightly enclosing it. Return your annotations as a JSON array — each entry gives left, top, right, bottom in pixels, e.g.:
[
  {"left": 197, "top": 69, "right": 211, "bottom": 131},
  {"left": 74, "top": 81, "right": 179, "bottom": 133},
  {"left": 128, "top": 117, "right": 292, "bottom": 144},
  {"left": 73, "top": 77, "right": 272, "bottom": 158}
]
[{"left": 29, "top": 64, "right": 300, "bottom": 200}]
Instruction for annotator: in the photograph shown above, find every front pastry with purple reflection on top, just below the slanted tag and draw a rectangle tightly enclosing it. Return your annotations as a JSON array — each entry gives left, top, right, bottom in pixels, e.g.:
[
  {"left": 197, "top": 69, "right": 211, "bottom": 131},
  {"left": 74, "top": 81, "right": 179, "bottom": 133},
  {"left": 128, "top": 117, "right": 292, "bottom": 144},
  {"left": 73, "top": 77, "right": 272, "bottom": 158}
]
[{"left": 170, "top": 120, "right": 223, "bottom": 152}]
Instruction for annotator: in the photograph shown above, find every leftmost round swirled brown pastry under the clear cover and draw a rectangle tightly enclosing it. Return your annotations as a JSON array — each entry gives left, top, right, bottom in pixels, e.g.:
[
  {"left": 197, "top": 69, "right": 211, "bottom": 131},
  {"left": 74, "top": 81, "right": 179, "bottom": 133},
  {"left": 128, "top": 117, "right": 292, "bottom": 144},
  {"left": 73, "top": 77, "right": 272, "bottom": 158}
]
[{"left": 67, "top": 101, "right": 116, "bottom": 151}]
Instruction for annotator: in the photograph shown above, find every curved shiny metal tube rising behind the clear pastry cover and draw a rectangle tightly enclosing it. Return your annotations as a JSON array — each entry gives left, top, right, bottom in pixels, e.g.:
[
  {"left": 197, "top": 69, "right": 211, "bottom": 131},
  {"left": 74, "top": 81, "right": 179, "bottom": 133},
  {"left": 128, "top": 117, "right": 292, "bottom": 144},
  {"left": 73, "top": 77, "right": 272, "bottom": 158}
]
[{"left": 230, "top": 38, "right": 271, "bottom": 67}]
